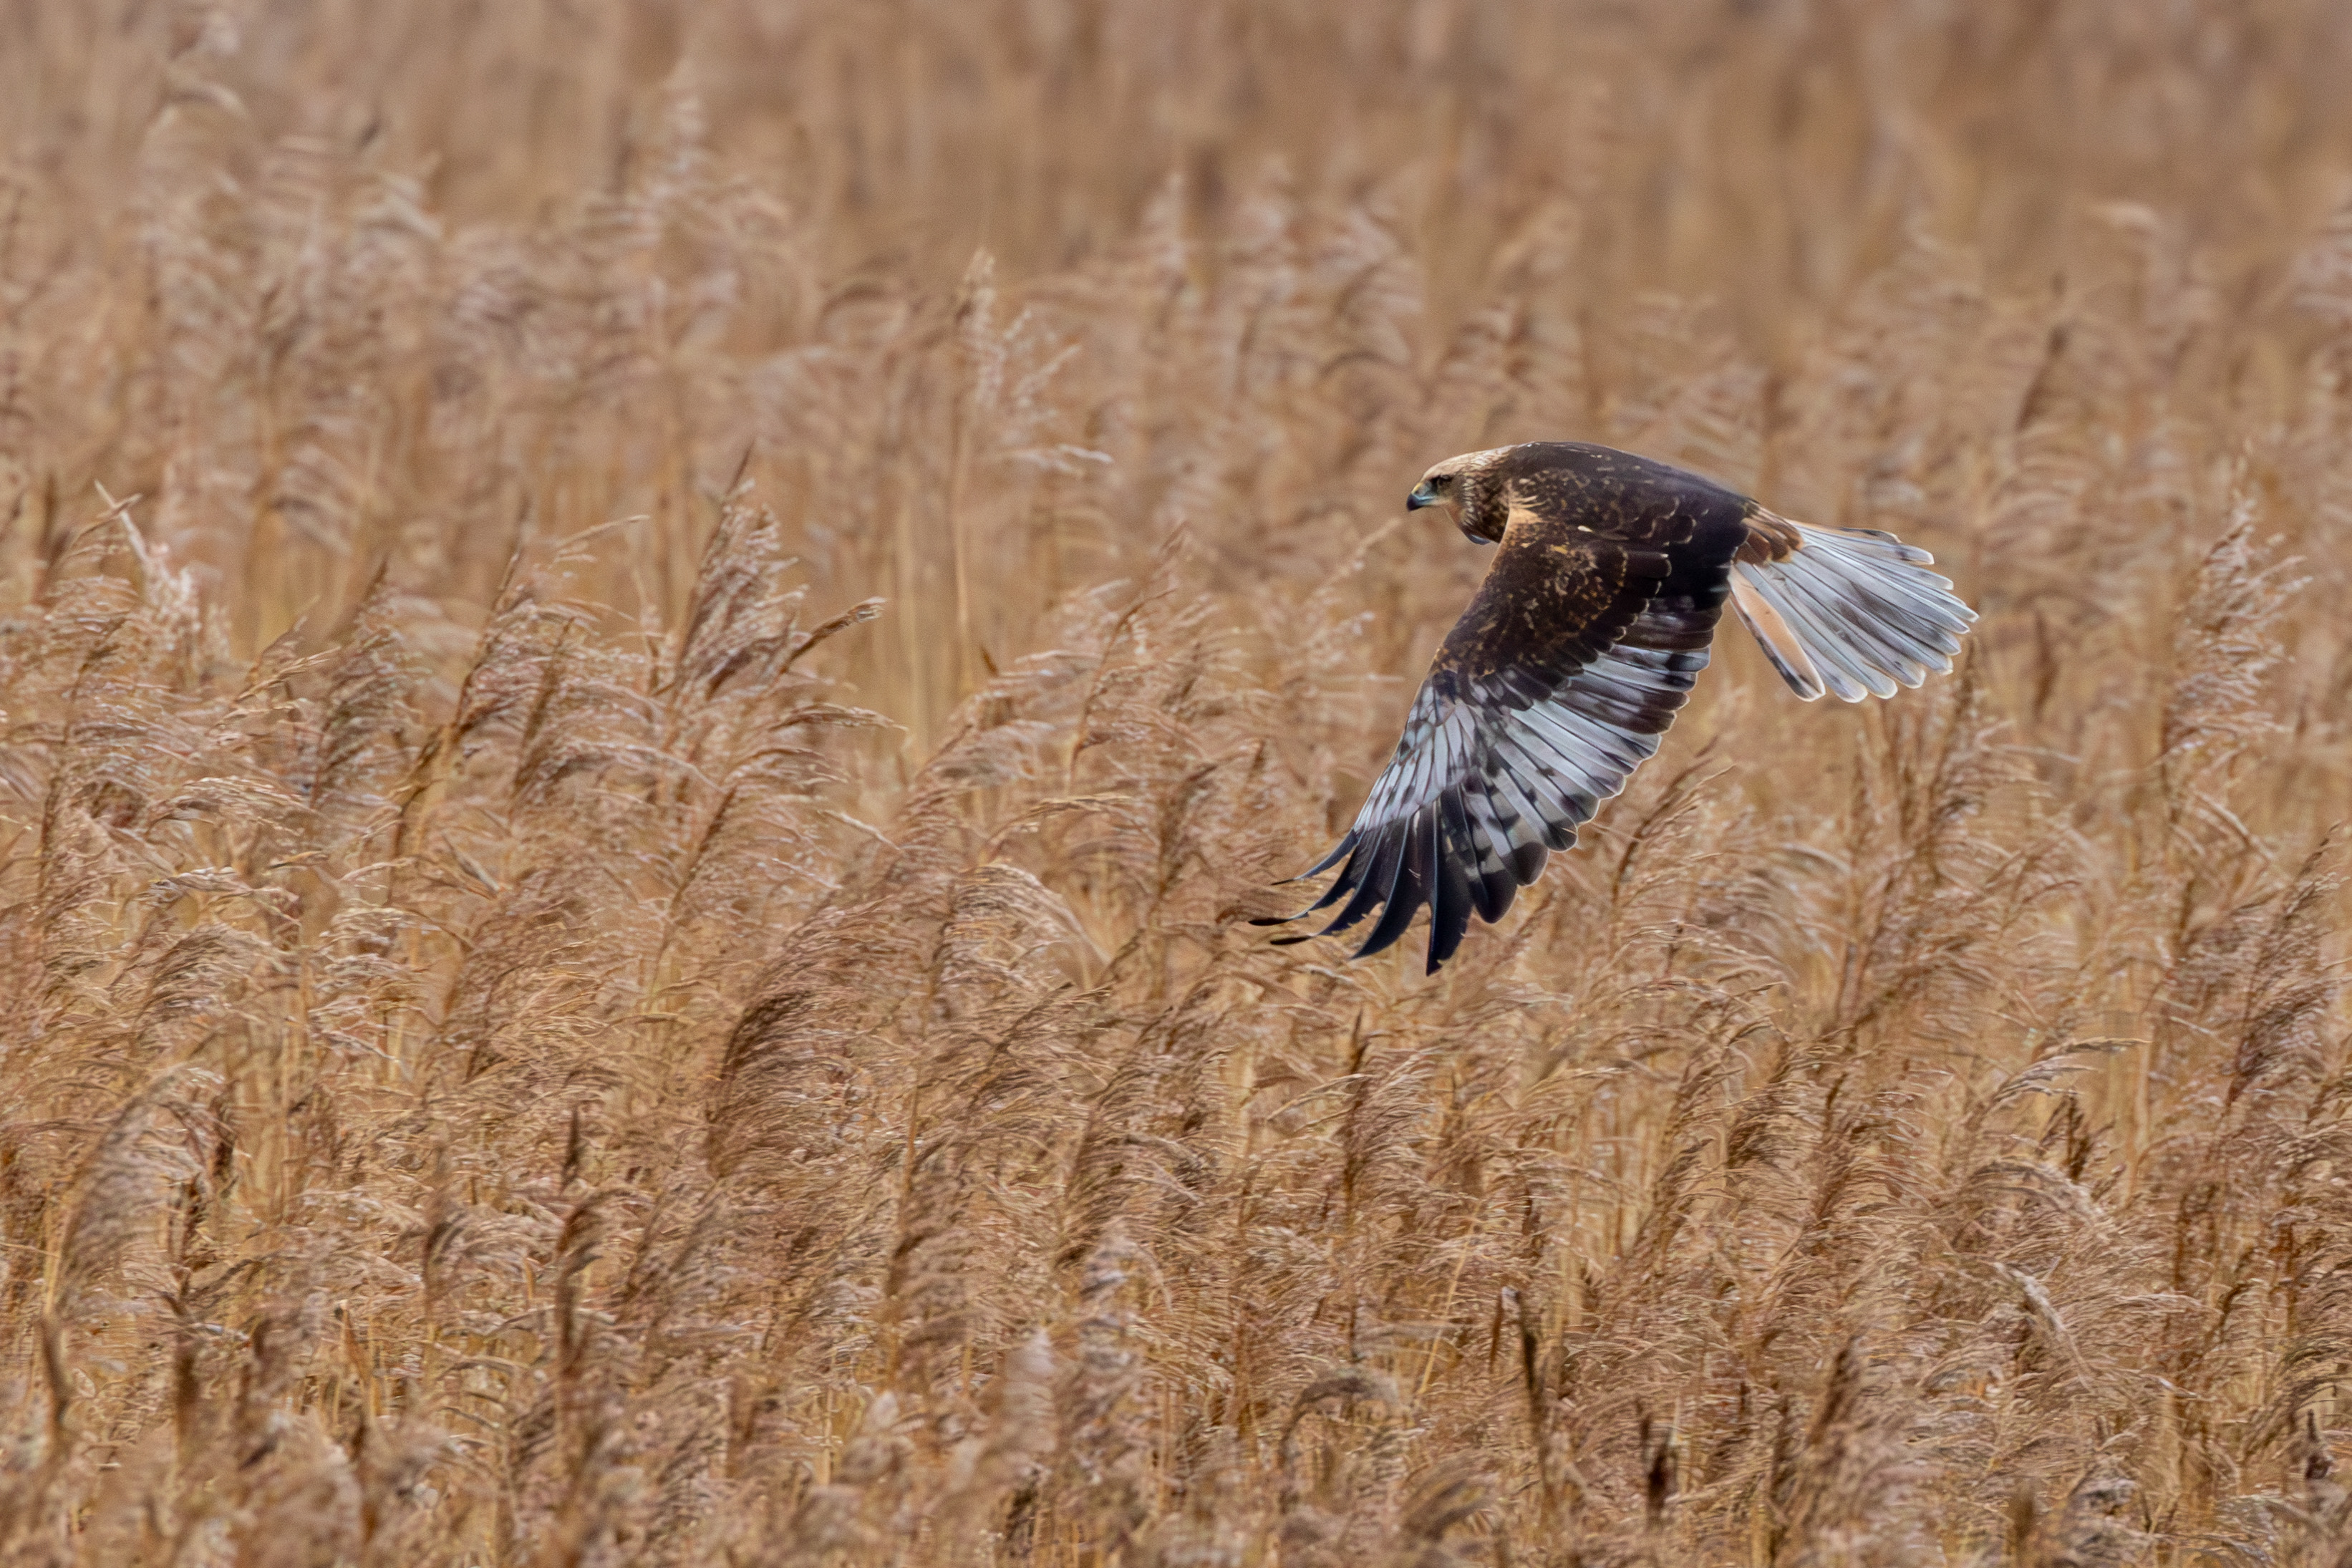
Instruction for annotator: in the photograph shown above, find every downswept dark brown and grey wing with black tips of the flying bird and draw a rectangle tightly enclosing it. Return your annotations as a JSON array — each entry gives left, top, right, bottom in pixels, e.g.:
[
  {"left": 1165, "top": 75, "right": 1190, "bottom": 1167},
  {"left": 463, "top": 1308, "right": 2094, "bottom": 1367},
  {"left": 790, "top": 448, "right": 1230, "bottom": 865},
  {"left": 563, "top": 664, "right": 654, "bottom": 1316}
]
[{"left": 1261, "top": 487, "right": 1745, "bottom": 973}]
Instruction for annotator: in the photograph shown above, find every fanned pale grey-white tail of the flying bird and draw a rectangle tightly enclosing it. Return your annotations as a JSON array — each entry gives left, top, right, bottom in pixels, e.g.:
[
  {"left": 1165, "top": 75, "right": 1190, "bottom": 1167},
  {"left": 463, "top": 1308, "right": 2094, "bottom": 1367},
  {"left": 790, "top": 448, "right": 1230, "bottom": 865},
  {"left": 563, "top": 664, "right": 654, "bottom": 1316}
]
[{"left": 1731, "top": 522, "right": 1975, "bottom": 703}]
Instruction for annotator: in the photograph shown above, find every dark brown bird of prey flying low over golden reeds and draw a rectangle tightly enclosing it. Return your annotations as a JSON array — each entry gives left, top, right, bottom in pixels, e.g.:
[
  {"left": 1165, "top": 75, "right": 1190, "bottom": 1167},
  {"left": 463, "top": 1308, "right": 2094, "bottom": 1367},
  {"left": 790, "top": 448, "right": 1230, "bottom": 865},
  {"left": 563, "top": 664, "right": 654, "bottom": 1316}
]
[{"left": 1256, "top": 442, "right": 1975, "bottom": 973}]
